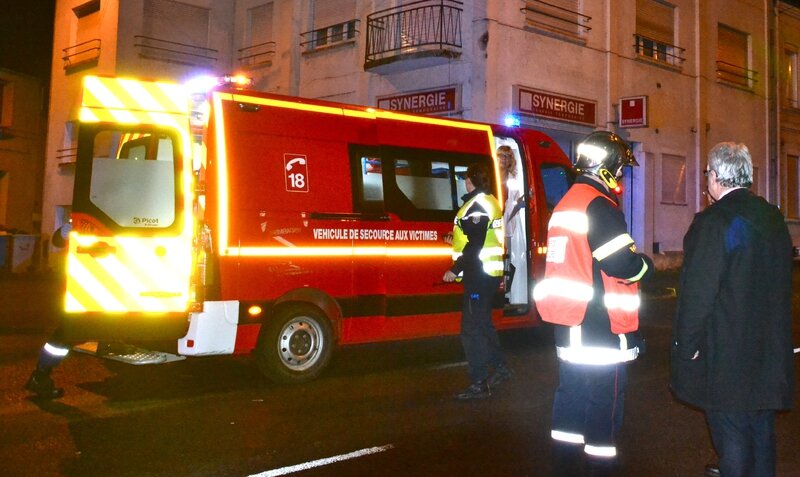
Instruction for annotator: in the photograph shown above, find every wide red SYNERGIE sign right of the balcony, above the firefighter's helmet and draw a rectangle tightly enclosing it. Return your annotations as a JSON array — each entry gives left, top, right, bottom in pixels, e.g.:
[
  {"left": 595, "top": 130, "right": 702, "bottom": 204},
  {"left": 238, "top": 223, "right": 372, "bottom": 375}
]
[{"left": 516, "top": 86, "right": 597, "bottom": 126}]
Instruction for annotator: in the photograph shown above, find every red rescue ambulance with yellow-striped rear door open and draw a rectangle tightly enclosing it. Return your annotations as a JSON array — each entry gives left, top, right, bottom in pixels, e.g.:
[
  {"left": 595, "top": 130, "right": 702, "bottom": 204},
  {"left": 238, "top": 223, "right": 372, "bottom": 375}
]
[{"left": 65, "top": 76, "right": 570, "bottom": 382}]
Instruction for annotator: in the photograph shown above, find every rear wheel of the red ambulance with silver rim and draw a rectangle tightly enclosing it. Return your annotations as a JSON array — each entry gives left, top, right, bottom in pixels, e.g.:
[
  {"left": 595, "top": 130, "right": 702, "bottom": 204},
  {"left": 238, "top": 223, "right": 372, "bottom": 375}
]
[{"left": 256, "top": 304, "right": 333, "bottom": 384}]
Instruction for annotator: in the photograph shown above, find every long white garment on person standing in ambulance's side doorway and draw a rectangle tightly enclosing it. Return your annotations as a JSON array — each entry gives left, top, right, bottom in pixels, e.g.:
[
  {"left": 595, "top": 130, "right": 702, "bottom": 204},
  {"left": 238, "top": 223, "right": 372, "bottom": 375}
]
[{"left": 503, "top": 177, "right": 528, "bottom": 304}]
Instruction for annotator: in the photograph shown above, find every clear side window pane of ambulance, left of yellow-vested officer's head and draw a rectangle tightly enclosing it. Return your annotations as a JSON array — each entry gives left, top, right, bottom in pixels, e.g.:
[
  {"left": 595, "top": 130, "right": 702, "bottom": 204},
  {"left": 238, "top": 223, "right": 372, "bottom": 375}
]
[{"left": 394, "top": 159, "right": 453, "bottom": 210}]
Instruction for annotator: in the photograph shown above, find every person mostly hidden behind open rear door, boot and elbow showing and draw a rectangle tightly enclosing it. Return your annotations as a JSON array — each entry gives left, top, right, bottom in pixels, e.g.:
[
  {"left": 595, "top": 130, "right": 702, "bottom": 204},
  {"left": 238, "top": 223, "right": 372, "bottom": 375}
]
[{"left": 25, "top": 222, "right": 72, "bottom": 399}]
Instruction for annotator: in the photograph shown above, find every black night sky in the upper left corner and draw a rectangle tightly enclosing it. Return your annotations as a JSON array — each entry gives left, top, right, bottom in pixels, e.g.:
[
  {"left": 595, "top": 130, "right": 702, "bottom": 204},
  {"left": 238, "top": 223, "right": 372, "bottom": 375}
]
[{"left": 0, "top": 0, "right": 55, "bottom": 83}]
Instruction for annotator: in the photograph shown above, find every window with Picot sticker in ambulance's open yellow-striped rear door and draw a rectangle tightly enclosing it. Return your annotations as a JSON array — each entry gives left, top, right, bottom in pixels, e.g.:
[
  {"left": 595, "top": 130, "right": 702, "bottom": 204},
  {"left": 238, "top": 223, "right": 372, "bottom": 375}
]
[{"left": 89, "top": 130, "right": 177, "bottom": 228}]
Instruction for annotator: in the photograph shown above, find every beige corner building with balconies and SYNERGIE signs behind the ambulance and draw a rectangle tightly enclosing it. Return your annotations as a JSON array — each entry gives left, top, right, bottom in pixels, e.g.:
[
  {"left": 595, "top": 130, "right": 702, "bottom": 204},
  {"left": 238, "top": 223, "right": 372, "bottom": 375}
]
[{"left": 42, "top": 0, "right": 800, "bottom": 266}]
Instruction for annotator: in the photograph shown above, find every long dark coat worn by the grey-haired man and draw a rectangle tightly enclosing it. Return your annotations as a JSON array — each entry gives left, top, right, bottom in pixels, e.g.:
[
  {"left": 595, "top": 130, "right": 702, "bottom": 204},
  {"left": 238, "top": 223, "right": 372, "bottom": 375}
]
[{"left": 671, "top": 189, "right": 795, "bottom": 411}]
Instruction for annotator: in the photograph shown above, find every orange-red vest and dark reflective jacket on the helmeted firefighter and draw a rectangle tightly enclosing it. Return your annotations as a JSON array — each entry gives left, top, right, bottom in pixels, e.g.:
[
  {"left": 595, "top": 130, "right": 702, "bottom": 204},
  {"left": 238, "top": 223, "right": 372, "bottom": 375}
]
[{"left": 533, "top": 177, "right": 652, "bottom": 364}]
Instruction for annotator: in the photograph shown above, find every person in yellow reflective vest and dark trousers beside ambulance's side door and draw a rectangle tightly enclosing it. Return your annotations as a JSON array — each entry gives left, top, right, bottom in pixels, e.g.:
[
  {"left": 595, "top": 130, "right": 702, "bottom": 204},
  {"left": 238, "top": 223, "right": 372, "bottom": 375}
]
[{"left": 442, "top": 164, "right": 513, "bottom": 400}]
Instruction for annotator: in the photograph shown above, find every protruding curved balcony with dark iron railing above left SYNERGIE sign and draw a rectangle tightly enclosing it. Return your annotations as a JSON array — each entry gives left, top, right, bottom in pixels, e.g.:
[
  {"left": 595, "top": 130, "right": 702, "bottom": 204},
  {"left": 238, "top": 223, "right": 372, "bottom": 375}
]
[{"left": 364, "top": 0, "right": 462, "bottom": 73}]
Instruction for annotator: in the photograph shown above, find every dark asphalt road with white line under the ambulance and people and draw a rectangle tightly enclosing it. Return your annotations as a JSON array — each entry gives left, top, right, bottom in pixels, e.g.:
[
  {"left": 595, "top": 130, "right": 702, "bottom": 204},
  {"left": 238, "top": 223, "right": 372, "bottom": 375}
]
[{"left": 0, "top": 275, "right": 800, "bottom": 477}]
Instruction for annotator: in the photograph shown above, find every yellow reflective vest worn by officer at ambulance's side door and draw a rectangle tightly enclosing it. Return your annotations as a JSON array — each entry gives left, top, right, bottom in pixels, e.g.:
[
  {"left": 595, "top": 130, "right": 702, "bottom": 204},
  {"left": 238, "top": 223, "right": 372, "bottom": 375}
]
[{"left": 452, "top": 189, "right": 503, "bottom": 277}]
